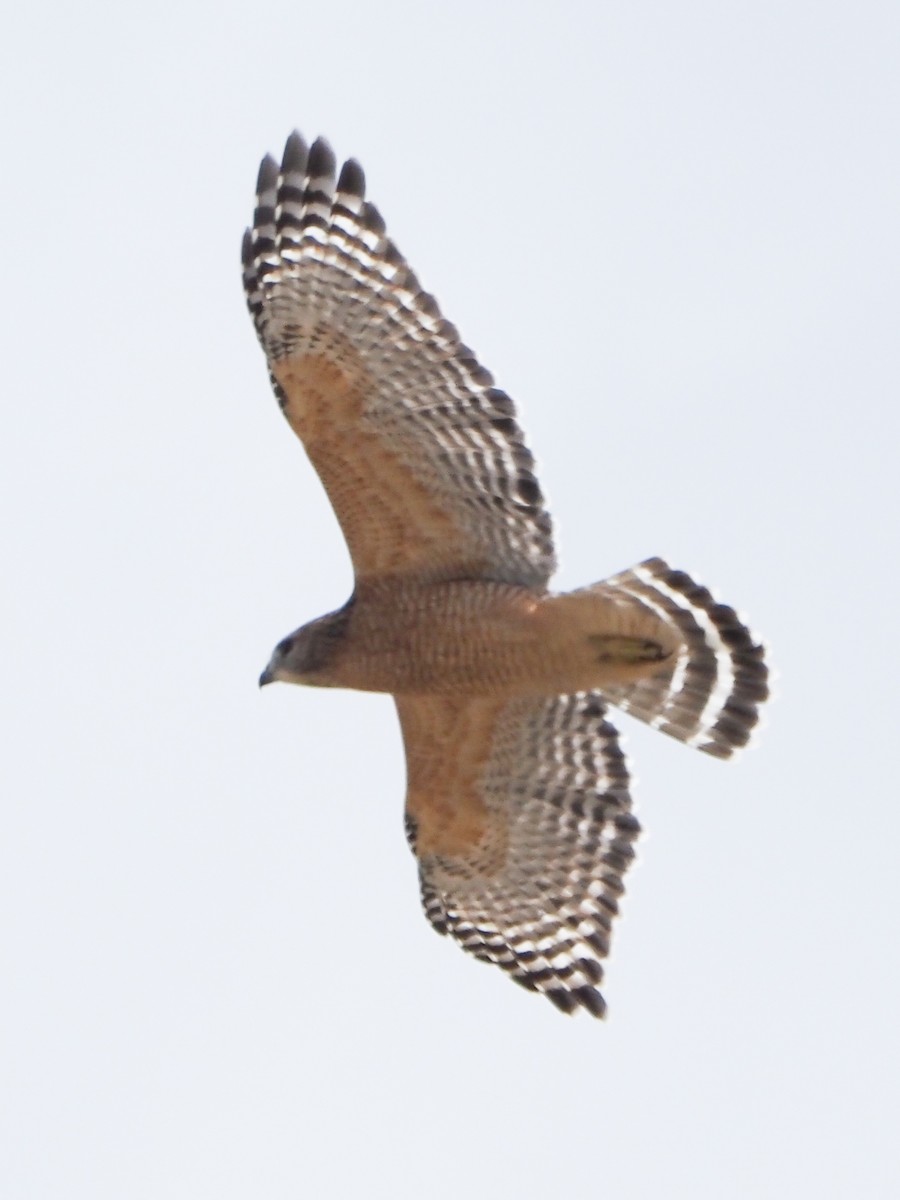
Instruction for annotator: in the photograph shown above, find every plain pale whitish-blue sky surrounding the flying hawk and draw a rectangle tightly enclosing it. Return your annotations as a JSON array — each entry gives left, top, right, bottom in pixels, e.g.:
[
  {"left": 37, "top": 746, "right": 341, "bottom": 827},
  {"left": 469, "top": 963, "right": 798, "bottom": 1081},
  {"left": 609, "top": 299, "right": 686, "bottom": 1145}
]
[{"left": 0, "top": 0, "right": 900, "bottom": 1200}]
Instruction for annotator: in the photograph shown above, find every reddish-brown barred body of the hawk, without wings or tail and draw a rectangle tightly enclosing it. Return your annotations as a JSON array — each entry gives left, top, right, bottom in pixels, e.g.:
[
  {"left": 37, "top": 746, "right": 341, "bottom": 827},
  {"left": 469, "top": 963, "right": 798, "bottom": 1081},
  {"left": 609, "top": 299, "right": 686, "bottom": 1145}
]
[{"left": 272, "top": 576, "right": 679, "bottom": 697}]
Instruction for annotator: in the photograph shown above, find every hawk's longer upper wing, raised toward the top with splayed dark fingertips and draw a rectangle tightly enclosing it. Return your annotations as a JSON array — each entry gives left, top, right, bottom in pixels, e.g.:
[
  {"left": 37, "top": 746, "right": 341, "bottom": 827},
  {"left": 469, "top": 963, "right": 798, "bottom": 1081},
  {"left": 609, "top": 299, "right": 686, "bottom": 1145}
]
[{"left": 242, "top": 133, "right": 554, "bottom": 587}]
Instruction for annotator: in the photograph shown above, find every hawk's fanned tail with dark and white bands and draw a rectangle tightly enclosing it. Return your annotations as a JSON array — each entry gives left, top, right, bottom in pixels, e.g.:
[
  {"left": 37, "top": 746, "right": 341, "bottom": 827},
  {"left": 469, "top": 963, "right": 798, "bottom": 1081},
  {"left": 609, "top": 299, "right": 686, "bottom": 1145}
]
[{"left": 600, "top": 558, "right": 769, "bottom": 758}]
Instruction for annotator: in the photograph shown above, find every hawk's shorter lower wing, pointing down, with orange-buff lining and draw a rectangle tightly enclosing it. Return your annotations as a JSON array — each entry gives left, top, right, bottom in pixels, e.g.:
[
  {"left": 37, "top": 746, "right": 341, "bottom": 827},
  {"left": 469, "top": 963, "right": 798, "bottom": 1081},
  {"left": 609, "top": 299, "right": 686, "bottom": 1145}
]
[{"left": 396, "top": 692, "right": 640, "bottom": 1016}]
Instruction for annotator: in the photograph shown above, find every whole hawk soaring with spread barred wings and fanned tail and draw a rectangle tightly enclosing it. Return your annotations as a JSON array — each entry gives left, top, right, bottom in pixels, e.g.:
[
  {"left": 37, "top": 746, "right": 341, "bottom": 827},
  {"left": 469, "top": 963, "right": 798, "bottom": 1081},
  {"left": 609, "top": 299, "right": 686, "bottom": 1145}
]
[{"left": 242, "top": 133, "right": 768, "bottom": 1016}]
